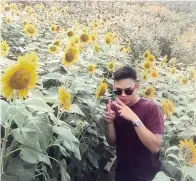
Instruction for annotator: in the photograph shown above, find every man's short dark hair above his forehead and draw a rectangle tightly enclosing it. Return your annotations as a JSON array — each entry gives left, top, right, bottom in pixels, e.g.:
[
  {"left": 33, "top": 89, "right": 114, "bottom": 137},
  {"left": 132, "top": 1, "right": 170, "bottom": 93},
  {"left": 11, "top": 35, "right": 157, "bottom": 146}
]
[{"left": 114, "top": 66, "right": 137, "bottom": 81}]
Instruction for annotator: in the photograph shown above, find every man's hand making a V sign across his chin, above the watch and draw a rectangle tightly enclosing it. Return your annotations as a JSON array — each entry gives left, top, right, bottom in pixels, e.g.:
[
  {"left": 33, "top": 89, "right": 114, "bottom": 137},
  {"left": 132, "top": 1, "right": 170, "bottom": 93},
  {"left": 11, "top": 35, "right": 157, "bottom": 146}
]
[{"left": 113, "top": 98, "right": 139, "bottom": 123}]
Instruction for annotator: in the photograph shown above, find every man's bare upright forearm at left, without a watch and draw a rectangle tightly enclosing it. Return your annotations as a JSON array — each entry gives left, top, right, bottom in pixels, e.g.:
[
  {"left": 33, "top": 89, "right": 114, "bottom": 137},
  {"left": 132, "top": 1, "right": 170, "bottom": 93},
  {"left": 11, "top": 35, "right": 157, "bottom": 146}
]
[{"left": 106, "top": 123, "right": 116, "bottom": 145}]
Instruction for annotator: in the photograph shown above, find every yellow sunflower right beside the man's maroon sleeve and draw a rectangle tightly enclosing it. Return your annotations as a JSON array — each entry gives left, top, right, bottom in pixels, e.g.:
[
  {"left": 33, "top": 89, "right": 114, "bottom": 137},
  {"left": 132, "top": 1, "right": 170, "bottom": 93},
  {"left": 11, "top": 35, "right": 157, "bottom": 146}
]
[{"left": 161, "top": 99, "right": 175, "bottom": 117}]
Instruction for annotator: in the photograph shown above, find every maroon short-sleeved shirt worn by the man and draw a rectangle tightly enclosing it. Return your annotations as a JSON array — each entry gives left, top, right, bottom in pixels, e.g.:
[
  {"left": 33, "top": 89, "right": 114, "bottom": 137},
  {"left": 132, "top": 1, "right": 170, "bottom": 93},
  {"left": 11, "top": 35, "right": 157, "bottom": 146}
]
[{"left": 112, "top": 97, "right": 164, "bottom": 181}]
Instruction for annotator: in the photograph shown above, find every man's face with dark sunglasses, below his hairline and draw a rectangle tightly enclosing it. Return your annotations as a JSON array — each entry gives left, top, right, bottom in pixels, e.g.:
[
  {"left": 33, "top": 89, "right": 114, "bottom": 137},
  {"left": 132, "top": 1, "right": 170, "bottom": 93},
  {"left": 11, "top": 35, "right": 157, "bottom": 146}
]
[{"left": 113, "top": 78, "right": 139, "bottom": 105}]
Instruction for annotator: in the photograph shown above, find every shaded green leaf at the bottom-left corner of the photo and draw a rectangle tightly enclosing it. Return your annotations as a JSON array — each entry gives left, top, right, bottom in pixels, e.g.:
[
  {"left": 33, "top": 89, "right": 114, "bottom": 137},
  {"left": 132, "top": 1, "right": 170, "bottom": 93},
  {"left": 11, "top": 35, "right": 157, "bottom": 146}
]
[{"left": 2, "top": 159, "right": 36, "bottom": 181}]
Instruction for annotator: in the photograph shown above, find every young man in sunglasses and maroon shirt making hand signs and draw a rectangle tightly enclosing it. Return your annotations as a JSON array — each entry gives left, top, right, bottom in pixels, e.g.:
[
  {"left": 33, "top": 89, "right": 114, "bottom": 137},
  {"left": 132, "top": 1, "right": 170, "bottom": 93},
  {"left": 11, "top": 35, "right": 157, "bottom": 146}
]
[{"left": 105, "top": 66, "right": 164, "bottom": 181}]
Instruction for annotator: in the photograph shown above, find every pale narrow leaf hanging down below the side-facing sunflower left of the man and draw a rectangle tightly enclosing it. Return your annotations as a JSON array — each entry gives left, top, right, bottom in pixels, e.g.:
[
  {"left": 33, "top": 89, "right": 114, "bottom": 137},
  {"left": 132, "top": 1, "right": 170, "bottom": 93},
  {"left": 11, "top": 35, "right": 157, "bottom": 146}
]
[{"left": 53, "top": 126, "right": 81, "bottom": 160}]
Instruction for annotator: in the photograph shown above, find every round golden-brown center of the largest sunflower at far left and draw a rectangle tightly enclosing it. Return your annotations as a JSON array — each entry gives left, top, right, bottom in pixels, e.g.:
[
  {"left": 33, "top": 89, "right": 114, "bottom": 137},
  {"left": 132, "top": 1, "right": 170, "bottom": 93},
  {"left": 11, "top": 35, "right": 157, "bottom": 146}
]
[{"left": 9, "top": 69, "right": 31, "bottom": 90}]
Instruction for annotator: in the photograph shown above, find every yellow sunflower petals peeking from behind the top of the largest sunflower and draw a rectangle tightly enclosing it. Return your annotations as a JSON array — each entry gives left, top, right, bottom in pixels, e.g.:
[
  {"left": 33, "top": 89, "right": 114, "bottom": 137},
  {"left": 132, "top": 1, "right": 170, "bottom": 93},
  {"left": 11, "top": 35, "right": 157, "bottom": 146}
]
[{"left": 17, "top": 52, "right": 38, "bottom": 67}]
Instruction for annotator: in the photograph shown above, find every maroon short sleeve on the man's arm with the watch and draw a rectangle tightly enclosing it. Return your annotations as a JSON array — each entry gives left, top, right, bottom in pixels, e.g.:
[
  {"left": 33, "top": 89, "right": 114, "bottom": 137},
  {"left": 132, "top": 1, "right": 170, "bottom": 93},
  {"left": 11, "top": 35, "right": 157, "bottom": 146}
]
[{"left": 144, "top": 102, "right": 164, "bottom": 134}]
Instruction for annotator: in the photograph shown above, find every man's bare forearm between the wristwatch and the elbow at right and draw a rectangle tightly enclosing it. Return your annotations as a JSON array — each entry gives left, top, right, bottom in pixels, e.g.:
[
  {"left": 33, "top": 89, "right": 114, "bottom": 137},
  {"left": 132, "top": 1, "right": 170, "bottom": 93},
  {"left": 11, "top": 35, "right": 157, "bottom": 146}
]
[{"left": 135, "top": 124, "right": 161, "bottom": 153}]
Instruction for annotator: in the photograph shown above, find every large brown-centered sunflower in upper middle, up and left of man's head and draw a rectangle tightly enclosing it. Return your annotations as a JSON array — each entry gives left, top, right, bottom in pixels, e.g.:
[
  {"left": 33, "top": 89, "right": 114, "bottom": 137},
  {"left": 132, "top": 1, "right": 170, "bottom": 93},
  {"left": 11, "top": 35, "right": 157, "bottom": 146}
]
[{"left": 62, "top": 46, "right": 79, "bottom": 66}]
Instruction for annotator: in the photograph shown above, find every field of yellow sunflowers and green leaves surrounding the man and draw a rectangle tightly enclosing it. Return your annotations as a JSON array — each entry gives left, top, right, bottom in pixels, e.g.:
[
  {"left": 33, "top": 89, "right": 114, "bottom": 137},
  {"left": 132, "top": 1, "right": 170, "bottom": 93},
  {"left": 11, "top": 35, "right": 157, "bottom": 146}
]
[{"left": 0, "top": 0, "right": 196, "bottom": 181}]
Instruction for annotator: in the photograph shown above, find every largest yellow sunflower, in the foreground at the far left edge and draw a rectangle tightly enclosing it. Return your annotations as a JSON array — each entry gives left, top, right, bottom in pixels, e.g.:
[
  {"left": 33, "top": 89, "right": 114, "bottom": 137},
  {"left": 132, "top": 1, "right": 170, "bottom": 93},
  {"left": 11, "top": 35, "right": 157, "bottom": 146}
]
[{"left": 1, "top": 59, "right": 38, "bottom": 100}]
